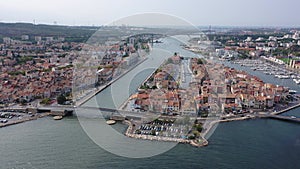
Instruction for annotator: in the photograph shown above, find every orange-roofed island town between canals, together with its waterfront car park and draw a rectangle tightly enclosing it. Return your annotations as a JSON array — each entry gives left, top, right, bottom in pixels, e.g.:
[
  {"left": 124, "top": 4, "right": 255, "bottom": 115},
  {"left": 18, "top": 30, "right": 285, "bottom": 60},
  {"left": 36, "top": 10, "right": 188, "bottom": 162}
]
[{"left": 123, "top": 50, "right": 298, "bottom": 143}]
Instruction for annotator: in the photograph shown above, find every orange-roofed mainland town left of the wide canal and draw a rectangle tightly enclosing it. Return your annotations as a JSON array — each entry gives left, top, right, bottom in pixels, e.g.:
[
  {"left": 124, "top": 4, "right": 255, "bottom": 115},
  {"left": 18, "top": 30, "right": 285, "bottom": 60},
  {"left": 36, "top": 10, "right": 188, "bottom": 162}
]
[{"left": 0, "top": 24, "right": 154, "bottom": 107}]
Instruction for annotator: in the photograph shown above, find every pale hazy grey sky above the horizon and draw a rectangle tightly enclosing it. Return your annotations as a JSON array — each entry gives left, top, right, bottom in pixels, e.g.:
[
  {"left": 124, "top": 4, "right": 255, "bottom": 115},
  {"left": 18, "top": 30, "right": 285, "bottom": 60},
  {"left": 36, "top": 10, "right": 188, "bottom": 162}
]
[{"left": 0, "top": 0, "right": 300, "bottom": 27}]
